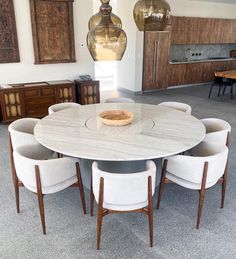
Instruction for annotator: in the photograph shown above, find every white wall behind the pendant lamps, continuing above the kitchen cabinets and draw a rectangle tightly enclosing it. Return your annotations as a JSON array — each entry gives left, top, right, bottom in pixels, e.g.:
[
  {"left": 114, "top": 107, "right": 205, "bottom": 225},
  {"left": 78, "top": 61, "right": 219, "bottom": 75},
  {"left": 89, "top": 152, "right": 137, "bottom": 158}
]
[{"left": 117, "top": 0, "right": 236, "bottom": 92}]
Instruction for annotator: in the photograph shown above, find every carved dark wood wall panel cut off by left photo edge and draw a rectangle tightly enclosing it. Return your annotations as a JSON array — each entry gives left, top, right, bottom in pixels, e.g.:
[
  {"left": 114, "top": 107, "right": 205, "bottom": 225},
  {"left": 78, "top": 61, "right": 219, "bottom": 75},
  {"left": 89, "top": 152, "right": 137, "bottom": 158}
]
[{"left": 0, "top": 0, "right": 20, "bottom": 63}]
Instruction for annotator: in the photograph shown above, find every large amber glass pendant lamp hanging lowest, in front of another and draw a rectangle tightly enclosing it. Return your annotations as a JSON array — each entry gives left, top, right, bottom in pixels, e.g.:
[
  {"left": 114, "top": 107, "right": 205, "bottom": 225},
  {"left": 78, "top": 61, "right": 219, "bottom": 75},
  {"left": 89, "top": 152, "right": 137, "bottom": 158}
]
[{"left": 87, "top": 0, "right": 127, "bottom": 61}]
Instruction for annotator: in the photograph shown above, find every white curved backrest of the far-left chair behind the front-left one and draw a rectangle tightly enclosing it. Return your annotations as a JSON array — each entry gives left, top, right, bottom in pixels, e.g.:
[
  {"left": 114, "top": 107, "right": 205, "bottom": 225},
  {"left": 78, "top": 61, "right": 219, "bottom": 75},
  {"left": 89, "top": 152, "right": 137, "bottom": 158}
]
[{"left": 8, "top": 118, "right": 40, "bottom": 150}]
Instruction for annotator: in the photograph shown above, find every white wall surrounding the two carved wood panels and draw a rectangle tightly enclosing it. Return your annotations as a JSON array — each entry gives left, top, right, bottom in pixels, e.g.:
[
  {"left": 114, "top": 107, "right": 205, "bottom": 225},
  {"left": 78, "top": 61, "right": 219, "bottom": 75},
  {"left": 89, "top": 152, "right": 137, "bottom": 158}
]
[{"left": 0, "top": 0, "right": 94, "bottom": 84}]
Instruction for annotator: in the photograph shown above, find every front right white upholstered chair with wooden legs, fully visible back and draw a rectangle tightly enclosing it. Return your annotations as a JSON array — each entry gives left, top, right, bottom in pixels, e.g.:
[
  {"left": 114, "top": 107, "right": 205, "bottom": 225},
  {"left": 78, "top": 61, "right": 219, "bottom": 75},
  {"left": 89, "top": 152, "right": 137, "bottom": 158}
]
[{"left": 157, "top": 141, "right": 228, "bottom": 229}]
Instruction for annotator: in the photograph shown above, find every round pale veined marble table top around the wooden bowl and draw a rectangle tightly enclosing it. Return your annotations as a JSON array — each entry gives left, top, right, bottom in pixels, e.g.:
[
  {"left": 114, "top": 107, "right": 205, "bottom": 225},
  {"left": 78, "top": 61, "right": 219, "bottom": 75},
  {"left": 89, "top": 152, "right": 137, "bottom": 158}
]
[{"left": 34, "top": 103, "right": 205, "bottom": 161}]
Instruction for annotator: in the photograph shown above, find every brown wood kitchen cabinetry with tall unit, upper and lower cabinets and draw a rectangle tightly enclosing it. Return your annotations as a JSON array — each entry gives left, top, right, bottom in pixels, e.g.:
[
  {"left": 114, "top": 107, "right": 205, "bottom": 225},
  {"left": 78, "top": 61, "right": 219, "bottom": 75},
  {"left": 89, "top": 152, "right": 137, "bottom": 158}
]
[{"left": 143, "top": 16, "right": 236, "bottom": 91}]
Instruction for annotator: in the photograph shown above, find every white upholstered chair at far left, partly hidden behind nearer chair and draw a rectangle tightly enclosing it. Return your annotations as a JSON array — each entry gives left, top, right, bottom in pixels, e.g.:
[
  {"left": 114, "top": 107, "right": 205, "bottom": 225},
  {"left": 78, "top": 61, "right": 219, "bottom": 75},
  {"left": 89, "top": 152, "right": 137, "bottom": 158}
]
[{"left": 8, "top": 118, "right": 53, "bottom": 213}]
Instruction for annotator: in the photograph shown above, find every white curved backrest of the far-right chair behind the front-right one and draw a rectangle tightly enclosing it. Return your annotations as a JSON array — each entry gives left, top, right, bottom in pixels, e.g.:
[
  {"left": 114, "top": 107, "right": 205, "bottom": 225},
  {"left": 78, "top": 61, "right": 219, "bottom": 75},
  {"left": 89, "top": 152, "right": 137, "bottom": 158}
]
[{"left": 201, "top": 118, "right": 231, "bottom": 146}]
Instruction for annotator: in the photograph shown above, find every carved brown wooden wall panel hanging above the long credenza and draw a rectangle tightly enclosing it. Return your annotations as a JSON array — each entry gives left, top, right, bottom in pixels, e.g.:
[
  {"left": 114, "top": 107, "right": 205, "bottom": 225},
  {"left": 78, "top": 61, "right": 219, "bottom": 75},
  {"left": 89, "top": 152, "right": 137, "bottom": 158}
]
[{"left": 30, "top": 0, "right": 76, "bottom": 64}]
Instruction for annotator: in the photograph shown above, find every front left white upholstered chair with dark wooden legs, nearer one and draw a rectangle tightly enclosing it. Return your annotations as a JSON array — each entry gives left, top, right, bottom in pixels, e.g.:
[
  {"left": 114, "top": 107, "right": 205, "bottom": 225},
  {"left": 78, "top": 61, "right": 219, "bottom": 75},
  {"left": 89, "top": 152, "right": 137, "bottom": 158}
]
[{"left": 13, "top": 144, "right": 86, "bottom": 234}]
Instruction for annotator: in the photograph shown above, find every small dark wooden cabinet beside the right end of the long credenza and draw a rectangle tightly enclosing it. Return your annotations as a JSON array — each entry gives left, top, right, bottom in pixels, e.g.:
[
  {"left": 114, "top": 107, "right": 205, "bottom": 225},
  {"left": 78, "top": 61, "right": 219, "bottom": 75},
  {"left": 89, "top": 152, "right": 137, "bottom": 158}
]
[{"left": 75, "top": 79, "right": 100, "bottom": 104}]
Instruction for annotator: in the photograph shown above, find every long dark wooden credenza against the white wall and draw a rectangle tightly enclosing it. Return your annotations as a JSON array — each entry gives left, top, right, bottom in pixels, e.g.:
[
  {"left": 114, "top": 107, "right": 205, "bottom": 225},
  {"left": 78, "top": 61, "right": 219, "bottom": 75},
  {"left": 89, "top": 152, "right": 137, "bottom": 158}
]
[{"left": 0, "top": 80, "right": 75, "bottom": 123}]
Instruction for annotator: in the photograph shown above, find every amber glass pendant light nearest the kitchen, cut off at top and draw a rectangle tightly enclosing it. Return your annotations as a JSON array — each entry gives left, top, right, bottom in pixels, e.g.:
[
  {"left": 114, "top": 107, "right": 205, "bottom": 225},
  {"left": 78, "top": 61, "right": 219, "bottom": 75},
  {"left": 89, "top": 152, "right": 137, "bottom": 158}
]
[{"left": 133, "top": 0, "right": 171, "bottom": 31}]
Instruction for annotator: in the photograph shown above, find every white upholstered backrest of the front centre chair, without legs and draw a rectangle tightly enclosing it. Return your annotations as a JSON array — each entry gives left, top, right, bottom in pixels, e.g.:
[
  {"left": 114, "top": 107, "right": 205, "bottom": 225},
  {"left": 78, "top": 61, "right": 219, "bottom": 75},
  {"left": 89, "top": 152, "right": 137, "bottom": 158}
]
[{"left": 92, "top": 161, "right": 156, "bottom": 210}]
